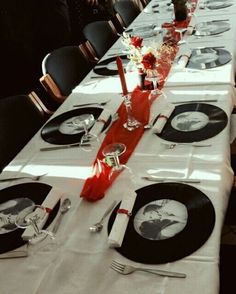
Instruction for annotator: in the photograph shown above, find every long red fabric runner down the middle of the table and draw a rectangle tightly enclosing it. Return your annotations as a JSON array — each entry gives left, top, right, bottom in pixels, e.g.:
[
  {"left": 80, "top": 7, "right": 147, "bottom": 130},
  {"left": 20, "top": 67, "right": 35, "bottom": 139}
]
[{"left": 81, "top": 6, "right": 195, "bottom": 201}]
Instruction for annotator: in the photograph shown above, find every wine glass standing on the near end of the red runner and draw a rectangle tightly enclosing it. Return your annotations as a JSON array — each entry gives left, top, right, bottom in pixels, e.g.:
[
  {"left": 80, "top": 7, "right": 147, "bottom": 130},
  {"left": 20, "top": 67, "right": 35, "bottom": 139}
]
[{"left": 102, "top": 143, "right": 127, "bottom": 179}]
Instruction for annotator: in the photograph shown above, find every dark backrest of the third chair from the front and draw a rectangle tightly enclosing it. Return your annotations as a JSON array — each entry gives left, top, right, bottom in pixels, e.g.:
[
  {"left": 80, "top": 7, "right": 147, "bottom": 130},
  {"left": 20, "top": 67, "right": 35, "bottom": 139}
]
[{"left": 83, "top": 20, "right": 118, "bottom": 59}]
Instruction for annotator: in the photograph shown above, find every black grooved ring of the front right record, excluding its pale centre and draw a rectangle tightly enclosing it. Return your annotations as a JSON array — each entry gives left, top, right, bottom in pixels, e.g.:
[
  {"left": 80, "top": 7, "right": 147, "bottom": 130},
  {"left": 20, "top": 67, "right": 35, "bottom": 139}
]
[{"left": 108, "top": 183, "right": 215, "bottom": 264}]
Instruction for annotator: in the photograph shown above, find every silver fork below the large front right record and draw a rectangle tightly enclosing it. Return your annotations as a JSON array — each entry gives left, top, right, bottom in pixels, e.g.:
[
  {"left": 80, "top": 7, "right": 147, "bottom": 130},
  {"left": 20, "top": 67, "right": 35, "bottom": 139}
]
[{"left": 111, "top": 260, "right": 186, "bottom": 278}]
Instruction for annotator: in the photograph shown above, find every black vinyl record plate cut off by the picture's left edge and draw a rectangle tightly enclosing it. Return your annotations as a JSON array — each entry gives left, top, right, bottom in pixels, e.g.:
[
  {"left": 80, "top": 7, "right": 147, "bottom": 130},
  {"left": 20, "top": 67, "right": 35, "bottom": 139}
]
[{"left": 0, "top": 182, "right": 60, "bottom": 253}]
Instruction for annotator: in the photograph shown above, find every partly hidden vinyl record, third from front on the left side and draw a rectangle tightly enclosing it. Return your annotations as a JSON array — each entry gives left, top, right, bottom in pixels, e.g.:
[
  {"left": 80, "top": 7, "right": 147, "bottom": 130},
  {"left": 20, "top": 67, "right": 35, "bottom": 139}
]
[{"left": 93, "top": 55, "right": 130, "bottom": 76}]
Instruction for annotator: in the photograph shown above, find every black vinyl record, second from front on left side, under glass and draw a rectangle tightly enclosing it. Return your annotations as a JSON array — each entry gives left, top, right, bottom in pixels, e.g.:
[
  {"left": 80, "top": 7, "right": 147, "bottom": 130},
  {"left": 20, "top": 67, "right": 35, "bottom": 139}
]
[{"left": 41, "top": 107, "right": 111, "bottom": 145}]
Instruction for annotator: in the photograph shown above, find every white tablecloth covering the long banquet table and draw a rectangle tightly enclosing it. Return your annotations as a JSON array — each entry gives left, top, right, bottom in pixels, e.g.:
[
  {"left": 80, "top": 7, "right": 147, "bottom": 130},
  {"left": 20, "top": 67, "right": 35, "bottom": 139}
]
[{"left": 0, "top": 0, "right": 236, "bottom": 294}]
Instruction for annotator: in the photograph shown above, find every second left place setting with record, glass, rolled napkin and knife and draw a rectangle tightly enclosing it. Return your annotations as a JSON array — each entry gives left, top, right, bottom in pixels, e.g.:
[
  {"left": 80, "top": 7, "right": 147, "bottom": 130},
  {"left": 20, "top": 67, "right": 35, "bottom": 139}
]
[{"left": 40, "top": 106, "right": 113, "bottom": 151}]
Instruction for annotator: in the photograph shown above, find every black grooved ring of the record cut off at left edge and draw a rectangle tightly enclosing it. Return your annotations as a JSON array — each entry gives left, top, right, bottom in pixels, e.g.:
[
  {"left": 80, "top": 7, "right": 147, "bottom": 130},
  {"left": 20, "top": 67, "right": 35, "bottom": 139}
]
[{"left": 0, "top": 182, "right": 60, "bottom": 254}]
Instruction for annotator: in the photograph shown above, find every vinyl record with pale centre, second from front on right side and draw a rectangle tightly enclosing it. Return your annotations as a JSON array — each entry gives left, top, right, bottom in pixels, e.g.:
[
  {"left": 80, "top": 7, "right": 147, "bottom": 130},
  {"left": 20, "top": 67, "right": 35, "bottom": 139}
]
[{"left": 157, "top": 103, "right": 228, "bottom": 143}]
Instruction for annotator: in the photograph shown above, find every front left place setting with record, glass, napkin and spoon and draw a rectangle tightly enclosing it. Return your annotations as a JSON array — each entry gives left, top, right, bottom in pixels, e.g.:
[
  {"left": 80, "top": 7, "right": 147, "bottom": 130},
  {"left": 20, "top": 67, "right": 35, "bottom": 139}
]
[{"left": 0, "top": 182, "right": 71, "bottom": 259}]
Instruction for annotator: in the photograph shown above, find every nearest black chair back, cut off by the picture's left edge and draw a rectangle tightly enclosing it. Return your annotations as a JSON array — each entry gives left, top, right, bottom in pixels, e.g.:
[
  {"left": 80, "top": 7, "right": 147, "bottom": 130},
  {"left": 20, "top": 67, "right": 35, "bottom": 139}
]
[{"left": 0, "top": 95, "right": 46, "bottom": 172}]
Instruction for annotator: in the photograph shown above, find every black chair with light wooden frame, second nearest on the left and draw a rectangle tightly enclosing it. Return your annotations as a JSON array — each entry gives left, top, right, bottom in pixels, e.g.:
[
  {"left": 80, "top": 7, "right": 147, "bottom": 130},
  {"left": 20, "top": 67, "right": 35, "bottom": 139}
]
[{"left": 40, "top": 46, "right": 92, "bottom": 103}]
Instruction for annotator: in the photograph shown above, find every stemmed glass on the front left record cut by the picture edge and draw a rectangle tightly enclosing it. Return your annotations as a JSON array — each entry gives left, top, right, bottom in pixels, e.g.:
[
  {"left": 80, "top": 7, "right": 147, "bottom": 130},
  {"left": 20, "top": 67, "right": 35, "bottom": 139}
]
[{"left": 15, "top": 205, "right": 55, "bottom": 249}]
